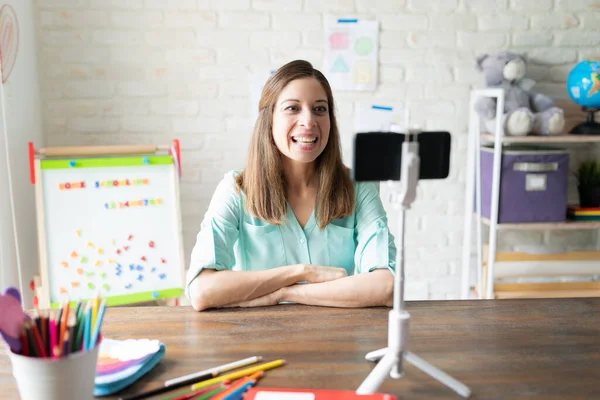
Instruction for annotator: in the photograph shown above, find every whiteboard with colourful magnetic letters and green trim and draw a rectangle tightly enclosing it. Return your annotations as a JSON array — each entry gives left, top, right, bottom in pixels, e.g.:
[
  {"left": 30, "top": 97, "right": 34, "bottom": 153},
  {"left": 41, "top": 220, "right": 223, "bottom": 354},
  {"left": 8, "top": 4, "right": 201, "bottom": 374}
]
[{"left": 37, "top": 156, "right": 184, "bottom": 307}]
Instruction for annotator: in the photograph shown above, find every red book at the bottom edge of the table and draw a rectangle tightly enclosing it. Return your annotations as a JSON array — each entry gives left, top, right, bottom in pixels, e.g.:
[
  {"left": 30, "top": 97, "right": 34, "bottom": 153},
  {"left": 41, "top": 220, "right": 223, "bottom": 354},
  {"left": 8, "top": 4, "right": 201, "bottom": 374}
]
[{"left": 244, "top": 388, "right": 396, "bottom": 400}]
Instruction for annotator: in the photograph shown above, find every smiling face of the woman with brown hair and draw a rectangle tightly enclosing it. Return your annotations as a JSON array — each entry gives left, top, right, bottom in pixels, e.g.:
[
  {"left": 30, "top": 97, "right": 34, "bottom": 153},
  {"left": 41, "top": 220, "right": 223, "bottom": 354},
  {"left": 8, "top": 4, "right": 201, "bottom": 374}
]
[{"left": 273, "top": 78, "right": 330, "bottom": 163}]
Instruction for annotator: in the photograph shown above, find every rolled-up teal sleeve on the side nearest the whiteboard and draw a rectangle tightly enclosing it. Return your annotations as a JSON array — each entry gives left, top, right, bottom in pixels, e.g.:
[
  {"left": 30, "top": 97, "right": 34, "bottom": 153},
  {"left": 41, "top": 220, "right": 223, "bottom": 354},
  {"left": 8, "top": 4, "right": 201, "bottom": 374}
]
[{"left": 185, "top": 172, "right": 241, "bottom": 298}]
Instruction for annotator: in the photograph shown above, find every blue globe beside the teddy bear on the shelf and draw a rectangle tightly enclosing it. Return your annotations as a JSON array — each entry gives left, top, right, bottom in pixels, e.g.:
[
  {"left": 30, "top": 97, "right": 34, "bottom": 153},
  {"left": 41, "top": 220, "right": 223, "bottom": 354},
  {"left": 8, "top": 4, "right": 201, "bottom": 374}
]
[{"left": 567, "top": 58, "right": 600, "bottom": 109}]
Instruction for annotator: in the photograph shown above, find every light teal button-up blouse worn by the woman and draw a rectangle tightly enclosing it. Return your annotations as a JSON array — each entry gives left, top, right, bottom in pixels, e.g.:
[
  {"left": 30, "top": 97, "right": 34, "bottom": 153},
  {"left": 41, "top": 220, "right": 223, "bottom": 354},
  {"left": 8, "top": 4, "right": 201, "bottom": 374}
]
[{"left": 186, "top": 171, "right": 396, "bottom": 297}]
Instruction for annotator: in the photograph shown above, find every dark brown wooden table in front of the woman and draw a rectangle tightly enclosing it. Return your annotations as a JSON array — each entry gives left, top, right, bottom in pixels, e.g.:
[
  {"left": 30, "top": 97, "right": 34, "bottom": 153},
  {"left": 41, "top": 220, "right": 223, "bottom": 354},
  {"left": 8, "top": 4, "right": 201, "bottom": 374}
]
[{"left": 0, "top": 298, "right": 600, "bottom": 400}]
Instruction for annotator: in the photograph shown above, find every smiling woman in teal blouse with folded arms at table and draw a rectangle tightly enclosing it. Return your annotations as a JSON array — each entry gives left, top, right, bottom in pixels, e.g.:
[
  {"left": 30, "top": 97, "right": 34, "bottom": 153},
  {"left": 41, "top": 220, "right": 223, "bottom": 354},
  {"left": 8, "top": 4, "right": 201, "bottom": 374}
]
[{"left": 186, "top": 60, "right": 396, "bottom": 311}]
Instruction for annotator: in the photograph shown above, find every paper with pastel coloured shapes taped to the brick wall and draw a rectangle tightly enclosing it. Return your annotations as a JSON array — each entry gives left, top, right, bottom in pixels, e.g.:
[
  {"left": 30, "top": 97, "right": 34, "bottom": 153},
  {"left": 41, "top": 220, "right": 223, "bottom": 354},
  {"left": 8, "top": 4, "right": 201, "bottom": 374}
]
[{"left": 323, "top": 19, "right": 379, "bottom": 90}]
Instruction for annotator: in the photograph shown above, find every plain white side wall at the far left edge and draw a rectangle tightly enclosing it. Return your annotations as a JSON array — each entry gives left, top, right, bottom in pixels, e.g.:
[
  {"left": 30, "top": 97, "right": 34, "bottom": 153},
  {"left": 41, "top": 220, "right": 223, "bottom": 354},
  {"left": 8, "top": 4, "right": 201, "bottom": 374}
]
[{"left": 0, "top": 0, "right": 43, "bottom": 306}]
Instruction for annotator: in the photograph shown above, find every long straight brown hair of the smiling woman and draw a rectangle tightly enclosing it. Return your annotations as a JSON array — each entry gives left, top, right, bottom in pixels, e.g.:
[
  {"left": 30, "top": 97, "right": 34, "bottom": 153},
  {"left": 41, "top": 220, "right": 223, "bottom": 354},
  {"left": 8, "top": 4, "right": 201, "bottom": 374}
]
[{"left": 236, "top": 60, "right": 354, "bottom": 229}]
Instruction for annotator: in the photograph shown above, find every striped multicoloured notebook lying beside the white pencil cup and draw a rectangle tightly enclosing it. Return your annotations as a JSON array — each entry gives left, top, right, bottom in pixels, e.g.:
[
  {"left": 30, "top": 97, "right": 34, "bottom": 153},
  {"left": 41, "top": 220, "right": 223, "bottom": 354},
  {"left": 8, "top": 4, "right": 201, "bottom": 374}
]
[{"left": 94, "top": 338, "right": 165, "bottom": 397}]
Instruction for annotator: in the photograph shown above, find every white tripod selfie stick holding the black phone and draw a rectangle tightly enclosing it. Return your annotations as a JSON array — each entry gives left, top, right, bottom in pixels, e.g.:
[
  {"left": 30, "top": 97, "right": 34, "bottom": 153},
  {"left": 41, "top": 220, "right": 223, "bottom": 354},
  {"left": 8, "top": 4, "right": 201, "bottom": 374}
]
[{"left": 356, "top": 129, "right": 471, "bottom": 398}]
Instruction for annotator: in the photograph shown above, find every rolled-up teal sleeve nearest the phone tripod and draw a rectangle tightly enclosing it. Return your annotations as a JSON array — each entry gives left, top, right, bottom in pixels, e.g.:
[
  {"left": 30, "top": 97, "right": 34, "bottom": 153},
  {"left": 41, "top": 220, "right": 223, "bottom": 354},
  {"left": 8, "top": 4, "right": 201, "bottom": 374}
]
[{"left": 354, "top": 182, "right": 396, "bottom": 274}]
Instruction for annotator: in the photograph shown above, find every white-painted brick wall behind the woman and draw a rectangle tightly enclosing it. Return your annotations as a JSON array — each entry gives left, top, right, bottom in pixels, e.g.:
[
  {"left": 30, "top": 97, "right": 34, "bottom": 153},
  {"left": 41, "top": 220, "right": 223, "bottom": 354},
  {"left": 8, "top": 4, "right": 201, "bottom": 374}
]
[{"left": 36, "top": 0, "right": 600, "bottom": 299}]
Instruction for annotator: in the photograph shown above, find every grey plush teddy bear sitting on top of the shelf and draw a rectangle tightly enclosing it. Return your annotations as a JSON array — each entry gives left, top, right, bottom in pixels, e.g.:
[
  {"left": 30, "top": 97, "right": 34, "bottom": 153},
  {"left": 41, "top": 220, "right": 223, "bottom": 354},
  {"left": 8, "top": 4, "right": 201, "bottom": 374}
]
[{"left": 475, "top": 51, "right": 565, "bottom": 136}]
